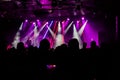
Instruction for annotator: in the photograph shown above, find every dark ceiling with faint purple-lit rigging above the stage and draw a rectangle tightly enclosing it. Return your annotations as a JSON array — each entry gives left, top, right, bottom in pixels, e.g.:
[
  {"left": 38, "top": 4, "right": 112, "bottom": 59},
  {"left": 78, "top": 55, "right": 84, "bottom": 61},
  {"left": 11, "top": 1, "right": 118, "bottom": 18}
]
[{"left": 0, "top": 0, "right": 118, "bottom": 19}]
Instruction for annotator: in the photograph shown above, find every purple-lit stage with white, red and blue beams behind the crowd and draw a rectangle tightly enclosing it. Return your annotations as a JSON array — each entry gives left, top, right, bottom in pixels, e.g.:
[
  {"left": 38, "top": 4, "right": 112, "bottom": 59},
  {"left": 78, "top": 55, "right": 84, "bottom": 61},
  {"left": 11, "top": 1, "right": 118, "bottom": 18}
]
[{"left": 11, "top": 18, "right": 98, "bottom": 48}]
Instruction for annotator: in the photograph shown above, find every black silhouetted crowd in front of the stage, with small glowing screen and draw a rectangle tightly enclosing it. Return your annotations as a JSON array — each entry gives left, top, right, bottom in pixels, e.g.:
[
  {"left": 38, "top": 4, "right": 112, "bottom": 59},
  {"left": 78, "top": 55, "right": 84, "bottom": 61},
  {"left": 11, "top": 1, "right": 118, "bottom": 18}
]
[{"left": 0, "top": 39, "right": 119, "bottom": 80}]
